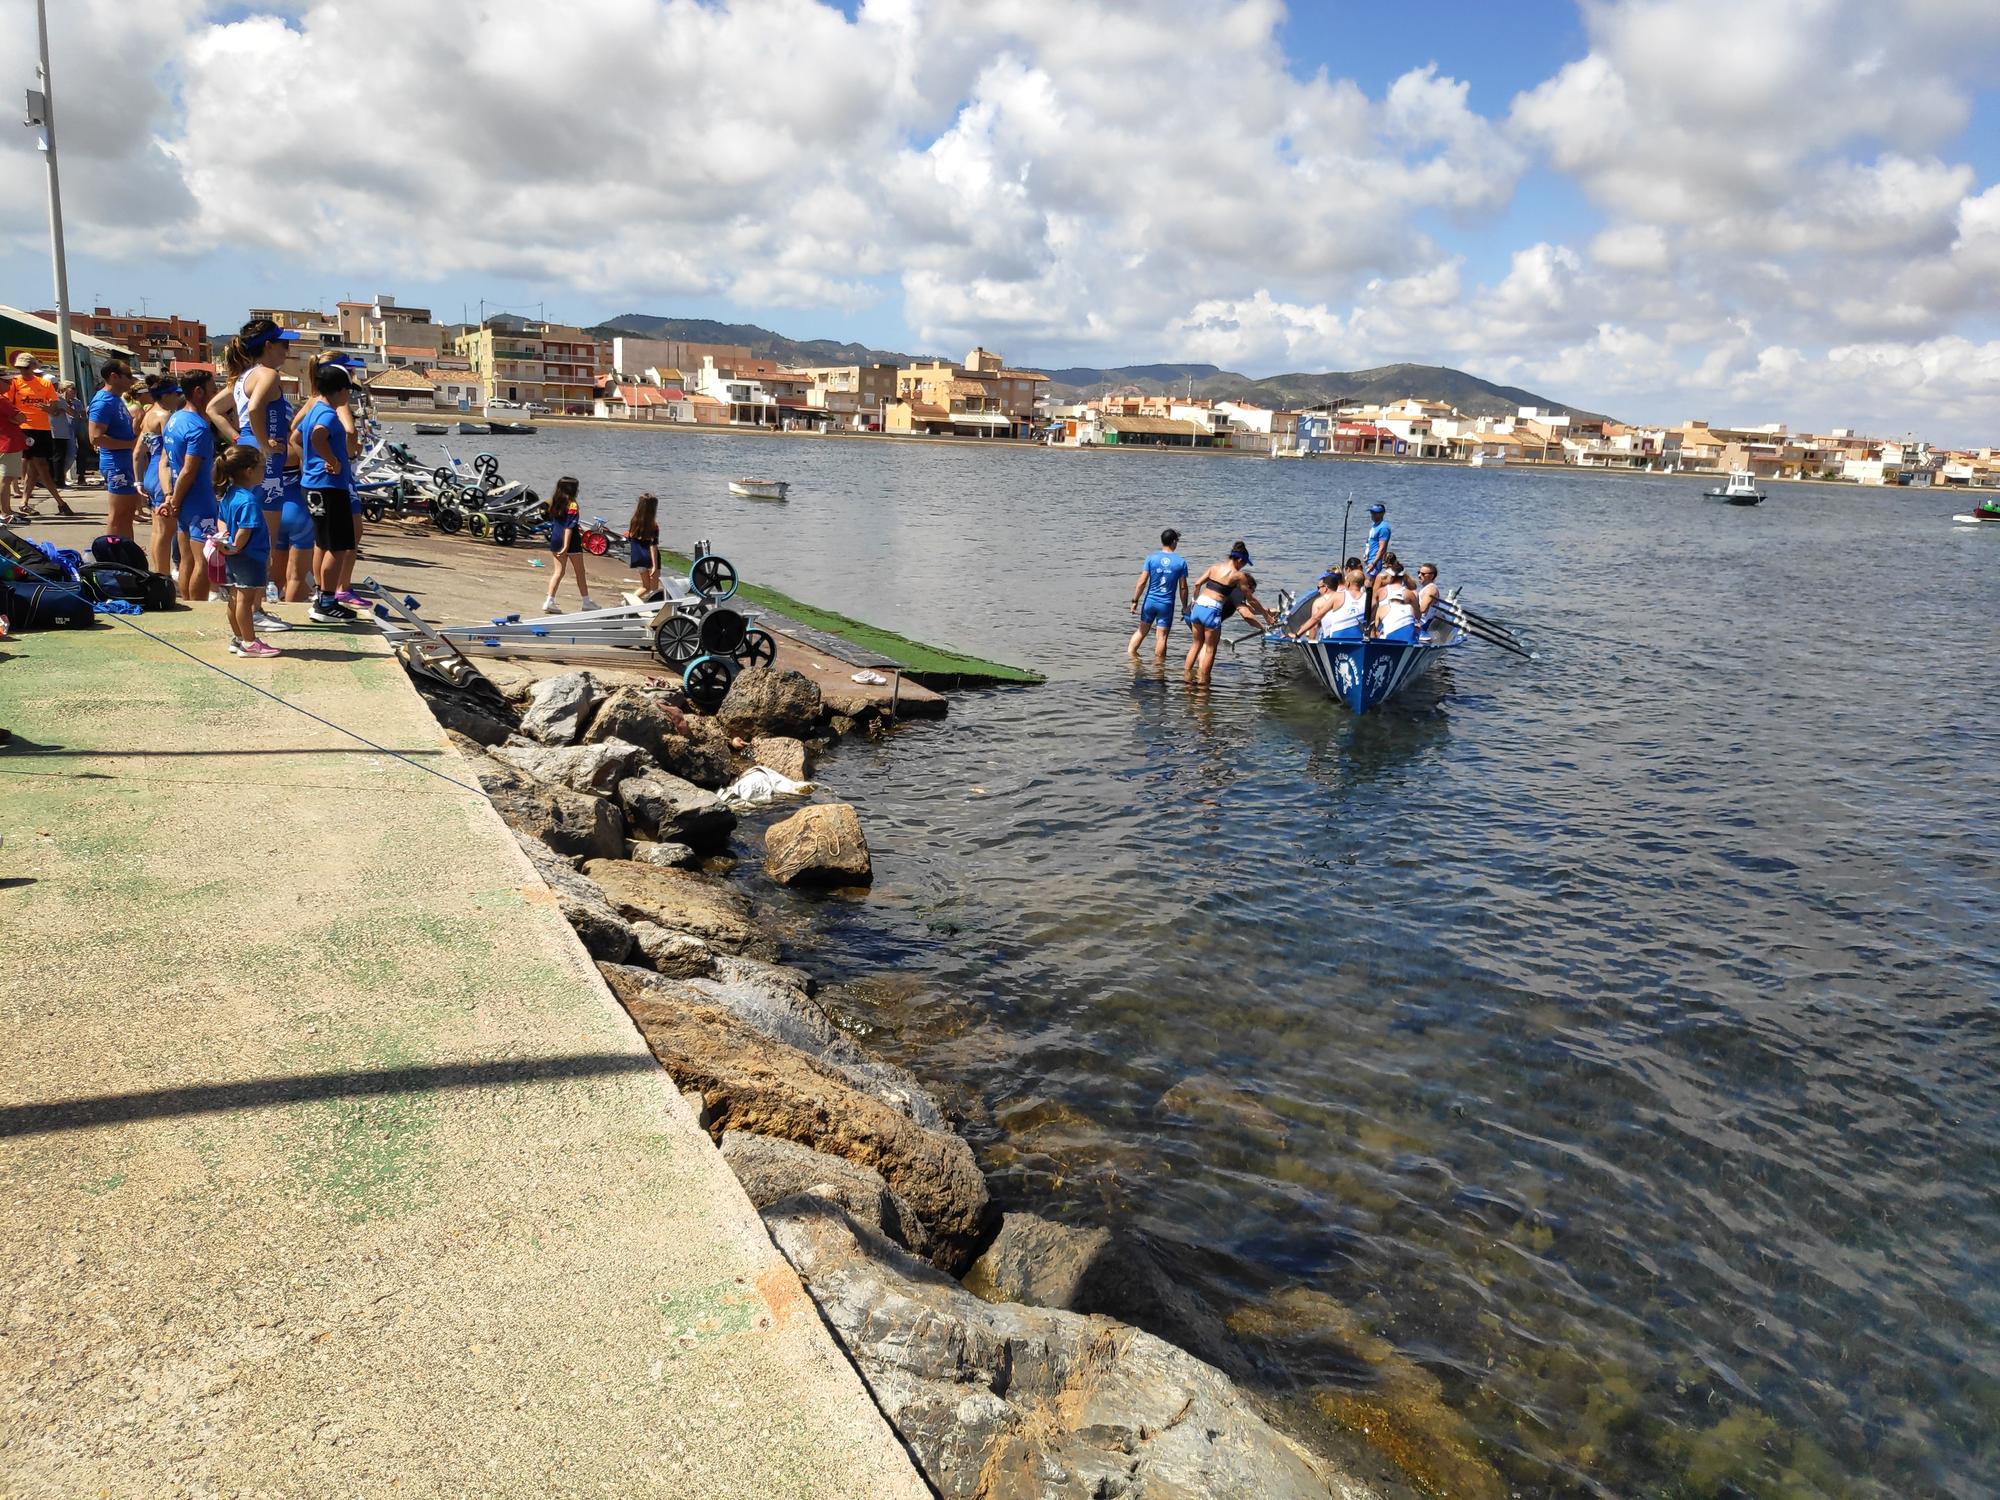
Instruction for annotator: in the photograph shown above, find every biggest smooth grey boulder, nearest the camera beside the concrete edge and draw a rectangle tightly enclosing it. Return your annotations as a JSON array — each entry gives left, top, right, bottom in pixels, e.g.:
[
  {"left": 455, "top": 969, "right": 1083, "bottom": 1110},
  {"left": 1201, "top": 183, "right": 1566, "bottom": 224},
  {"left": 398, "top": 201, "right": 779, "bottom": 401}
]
[{"left": 764, "top": 1196, "right": 1376, "bottom": 1500}]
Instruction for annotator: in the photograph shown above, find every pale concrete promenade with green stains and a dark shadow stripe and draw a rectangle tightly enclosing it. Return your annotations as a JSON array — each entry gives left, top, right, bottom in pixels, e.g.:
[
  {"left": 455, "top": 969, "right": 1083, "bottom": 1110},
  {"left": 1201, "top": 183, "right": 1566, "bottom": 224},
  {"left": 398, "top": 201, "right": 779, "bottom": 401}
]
[{"left": 0, "top": 604, "right": 928, "bottom": 1500}]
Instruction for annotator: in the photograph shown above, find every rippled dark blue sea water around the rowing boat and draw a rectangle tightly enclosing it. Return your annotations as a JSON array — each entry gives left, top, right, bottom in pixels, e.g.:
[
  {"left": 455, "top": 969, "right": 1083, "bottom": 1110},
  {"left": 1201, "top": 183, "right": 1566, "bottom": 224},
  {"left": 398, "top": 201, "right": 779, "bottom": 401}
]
[{"left": 430, "top": 432, "right": 2000, "bottom": 1498}]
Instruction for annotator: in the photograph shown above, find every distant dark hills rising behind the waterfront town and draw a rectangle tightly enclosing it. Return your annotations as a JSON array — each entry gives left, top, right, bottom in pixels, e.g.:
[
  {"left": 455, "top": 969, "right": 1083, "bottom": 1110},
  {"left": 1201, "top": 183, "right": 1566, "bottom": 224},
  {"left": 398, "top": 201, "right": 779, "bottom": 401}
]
[{"left": 590, "top": 312, "right": 1598, "bottom": 418}]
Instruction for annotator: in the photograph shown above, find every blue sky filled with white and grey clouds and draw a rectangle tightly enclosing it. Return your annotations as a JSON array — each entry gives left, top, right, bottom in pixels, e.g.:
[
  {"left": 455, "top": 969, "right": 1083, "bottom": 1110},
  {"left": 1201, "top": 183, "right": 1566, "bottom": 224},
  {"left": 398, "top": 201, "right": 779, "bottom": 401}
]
[{"left": 0, "top": 0, "right": 2000, "bottom": 444}]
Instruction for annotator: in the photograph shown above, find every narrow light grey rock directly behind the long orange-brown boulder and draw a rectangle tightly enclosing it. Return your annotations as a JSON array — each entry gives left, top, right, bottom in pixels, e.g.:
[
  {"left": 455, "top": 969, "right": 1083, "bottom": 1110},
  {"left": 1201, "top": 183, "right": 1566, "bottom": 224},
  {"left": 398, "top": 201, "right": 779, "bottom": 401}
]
[{"left": 600, "top": 956, "right": 950, "bottom": 1130}]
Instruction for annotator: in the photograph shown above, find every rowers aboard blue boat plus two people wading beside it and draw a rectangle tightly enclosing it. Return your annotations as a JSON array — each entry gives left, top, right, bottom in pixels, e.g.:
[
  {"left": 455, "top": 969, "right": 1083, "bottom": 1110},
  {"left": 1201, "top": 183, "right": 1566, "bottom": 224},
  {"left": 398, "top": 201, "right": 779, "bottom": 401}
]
[{"left": 1126, "top": 504, "right": 1440, "bottom": 682}]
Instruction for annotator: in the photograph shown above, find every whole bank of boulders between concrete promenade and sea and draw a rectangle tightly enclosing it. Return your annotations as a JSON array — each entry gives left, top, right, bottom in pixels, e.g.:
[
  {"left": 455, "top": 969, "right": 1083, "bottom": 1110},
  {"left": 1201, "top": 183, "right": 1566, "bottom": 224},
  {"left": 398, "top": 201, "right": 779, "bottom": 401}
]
[{"left": 418, "top": 668, "right": 1410, "bottom": 1500}]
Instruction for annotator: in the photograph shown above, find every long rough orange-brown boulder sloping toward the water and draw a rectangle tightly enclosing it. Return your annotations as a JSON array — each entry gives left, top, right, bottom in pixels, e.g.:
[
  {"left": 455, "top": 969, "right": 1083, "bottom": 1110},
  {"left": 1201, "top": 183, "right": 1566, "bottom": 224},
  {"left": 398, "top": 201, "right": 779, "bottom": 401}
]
[{"left": 624, "top": 988, "right": 988, "bottom": 1270}]
